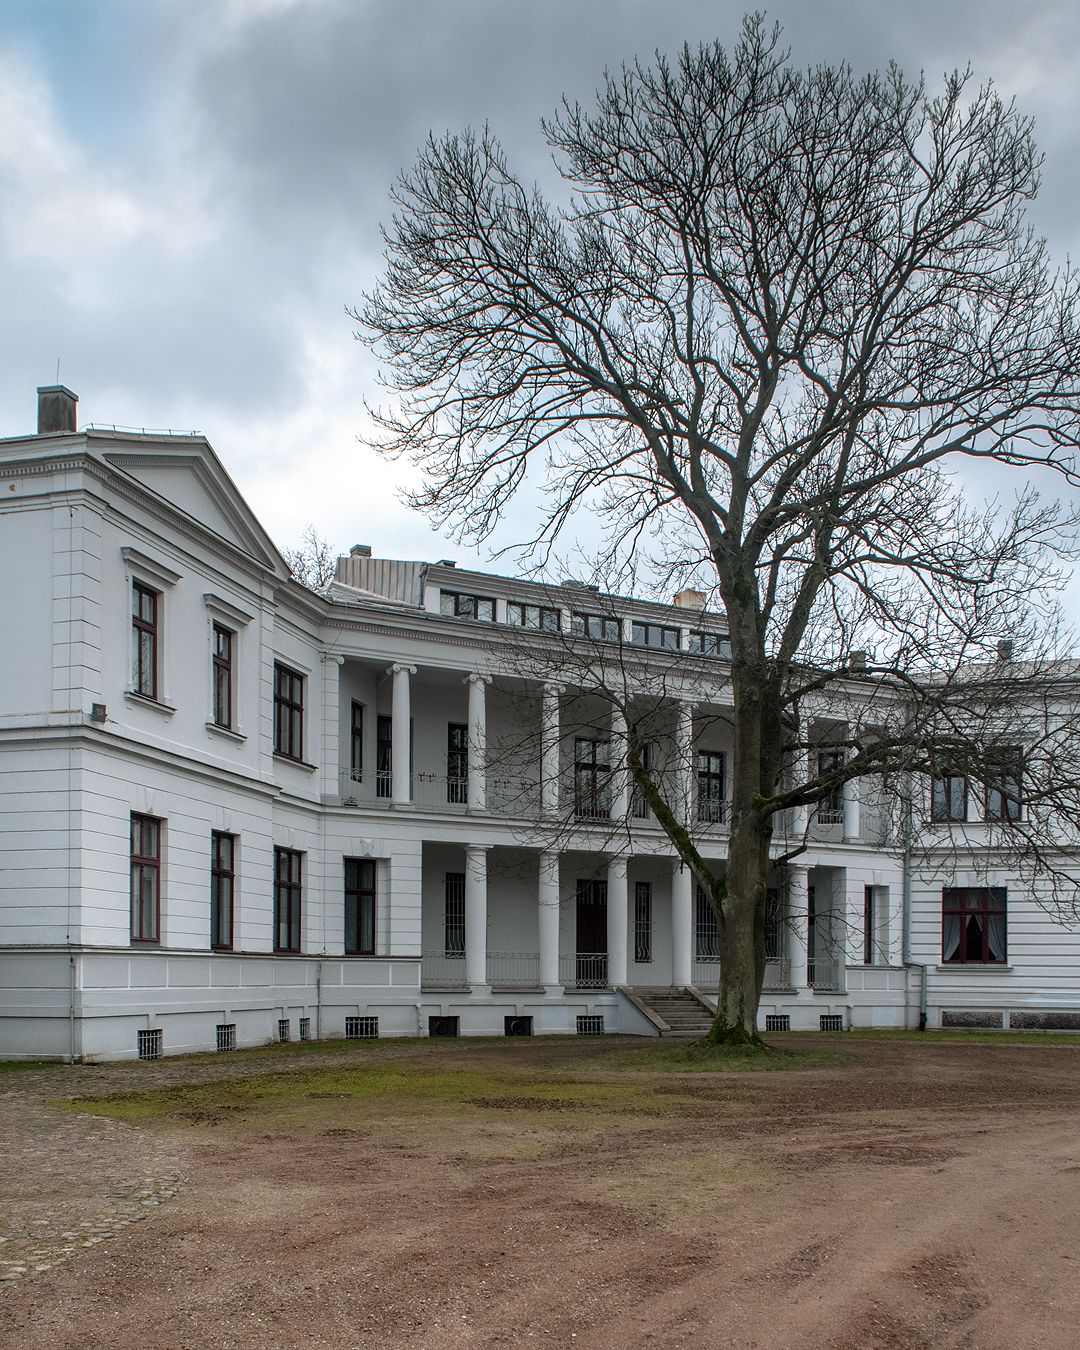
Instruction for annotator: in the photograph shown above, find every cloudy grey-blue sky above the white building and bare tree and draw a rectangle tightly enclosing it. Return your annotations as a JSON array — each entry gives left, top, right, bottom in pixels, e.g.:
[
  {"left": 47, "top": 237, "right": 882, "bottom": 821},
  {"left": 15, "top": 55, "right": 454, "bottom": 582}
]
[{"left": 0, "top": 0, "right": 1080, "bottom": 575}]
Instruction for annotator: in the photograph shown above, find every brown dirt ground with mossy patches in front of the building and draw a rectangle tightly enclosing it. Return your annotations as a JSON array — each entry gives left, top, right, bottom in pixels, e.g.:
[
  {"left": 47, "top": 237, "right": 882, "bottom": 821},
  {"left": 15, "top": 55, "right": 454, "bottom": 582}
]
[{"left": 0, "top": 1037, "right": 1080, "bottom": 1350}]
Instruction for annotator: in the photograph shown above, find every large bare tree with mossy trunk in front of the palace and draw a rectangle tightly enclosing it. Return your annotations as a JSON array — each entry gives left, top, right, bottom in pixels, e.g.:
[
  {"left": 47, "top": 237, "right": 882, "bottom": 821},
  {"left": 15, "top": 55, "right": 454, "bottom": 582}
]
[{"left": 355, "top": 16, "right": 1080, "bottom": 1041}]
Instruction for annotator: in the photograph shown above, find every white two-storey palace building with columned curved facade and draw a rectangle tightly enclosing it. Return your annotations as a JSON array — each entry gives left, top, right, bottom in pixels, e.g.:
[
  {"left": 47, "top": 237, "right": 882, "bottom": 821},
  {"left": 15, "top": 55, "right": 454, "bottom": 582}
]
[{"left": 0, "top": 386, "right": 1080, "bottom": 1060}]
